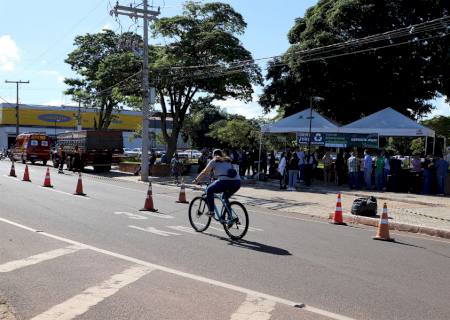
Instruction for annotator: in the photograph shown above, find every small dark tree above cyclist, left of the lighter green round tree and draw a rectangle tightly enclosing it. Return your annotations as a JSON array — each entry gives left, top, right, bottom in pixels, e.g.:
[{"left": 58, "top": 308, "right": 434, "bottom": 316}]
[{"left": 182, "top": 98, "right": 227, "bottom": 148}]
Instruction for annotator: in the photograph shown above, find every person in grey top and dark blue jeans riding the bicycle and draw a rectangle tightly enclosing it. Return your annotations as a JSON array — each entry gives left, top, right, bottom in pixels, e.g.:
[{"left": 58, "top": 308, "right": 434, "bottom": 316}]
[{"left": 194, "top": 149, "right": 241, "bottom": 216}]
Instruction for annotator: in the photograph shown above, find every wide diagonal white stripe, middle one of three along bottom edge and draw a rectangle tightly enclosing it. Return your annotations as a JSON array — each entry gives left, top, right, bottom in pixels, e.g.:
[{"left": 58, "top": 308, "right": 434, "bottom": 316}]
[{"left": 32, "top": 265, "right": 155, "bottom": 320}]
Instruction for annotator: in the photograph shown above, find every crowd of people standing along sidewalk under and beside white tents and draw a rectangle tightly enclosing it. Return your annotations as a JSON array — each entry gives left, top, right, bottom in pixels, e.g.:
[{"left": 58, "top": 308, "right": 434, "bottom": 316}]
[{"left": 156, "top": 148, "right": 449, "bottom": 195}]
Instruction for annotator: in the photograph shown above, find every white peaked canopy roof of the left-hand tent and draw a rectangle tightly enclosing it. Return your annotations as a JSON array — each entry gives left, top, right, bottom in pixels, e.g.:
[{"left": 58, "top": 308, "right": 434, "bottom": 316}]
[{"left": 262, "top": 108, "right": 340, "bottom": 133}]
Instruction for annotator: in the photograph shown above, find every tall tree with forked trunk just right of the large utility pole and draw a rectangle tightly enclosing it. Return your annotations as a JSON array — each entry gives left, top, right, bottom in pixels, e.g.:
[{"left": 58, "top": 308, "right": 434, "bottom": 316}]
[{"left": 150, "top": 2, "right": 262, "bottom": 157}]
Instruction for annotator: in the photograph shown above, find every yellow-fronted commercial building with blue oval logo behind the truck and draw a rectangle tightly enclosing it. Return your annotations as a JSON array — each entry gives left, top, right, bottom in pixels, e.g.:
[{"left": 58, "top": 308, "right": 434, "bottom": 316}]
[{"left": 0, "top": 103, "right": 188, "bottom": 149}]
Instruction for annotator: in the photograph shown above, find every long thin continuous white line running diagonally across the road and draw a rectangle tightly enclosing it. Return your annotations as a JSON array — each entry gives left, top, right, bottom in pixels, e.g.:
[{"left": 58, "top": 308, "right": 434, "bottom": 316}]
[{"left": 0, "top": 218, "right": 354, "bottom": 320}]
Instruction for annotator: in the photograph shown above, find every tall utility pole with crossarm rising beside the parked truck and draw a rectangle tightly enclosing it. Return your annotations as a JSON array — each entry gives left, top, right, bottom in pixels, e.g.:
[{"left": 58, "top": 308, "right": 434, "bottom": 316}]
[{"left": 111, "top": 0, "right": 160, "bottom": 181}]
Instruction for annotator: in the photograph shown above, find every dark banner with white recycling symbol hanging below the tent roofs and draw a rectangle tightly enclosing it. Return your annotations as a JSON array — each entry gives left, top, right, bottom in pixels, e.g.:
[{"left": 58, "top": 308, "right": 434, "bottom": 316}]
[{"left": 297, "top": 132, "right": 378, "bottom": 149}]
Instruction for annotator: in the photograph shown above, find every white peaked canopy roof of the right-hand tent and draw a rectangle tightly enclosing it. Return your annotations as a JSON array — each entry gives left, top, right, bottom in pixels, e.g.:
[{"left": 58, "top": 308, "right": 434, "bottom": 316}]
[{"left": 339, "top": 108, "right": 435, "bottom": 137}]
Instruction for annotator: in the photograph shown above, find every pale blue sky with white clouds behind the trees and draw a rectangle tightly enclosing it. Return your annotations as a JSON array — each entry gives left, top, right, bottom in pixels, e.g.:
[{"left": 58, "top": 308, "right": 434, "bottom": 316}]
[{"left": 0, "top": 0, "right": 450, "bottom": 117}]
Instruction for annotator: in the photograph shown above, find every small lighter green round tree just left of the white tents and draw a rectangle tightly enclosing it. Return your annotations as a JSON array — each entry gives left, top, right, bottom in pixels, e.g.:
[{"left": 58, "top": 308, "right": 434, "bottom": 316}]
[{"left": 208, "top": 116, "right": 261, "bottom": 148}]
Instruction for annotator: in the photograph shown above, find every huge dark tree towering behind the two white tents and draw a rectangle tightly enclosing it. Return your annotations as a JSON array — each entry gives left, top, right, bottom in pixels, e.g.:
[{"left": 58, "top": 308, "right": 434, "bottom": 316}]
[{"left": 260, "top": 0, "right": 450, "bottom": 123}]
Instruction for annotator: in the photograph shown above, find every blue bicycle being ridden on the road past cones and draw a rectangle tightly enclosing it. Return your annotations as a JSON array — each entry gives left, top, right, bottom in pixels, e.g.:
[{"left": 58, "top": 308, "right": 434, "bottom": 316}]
[{"left": 189, "top": 182, "right": 249, "bottom": 240}]
